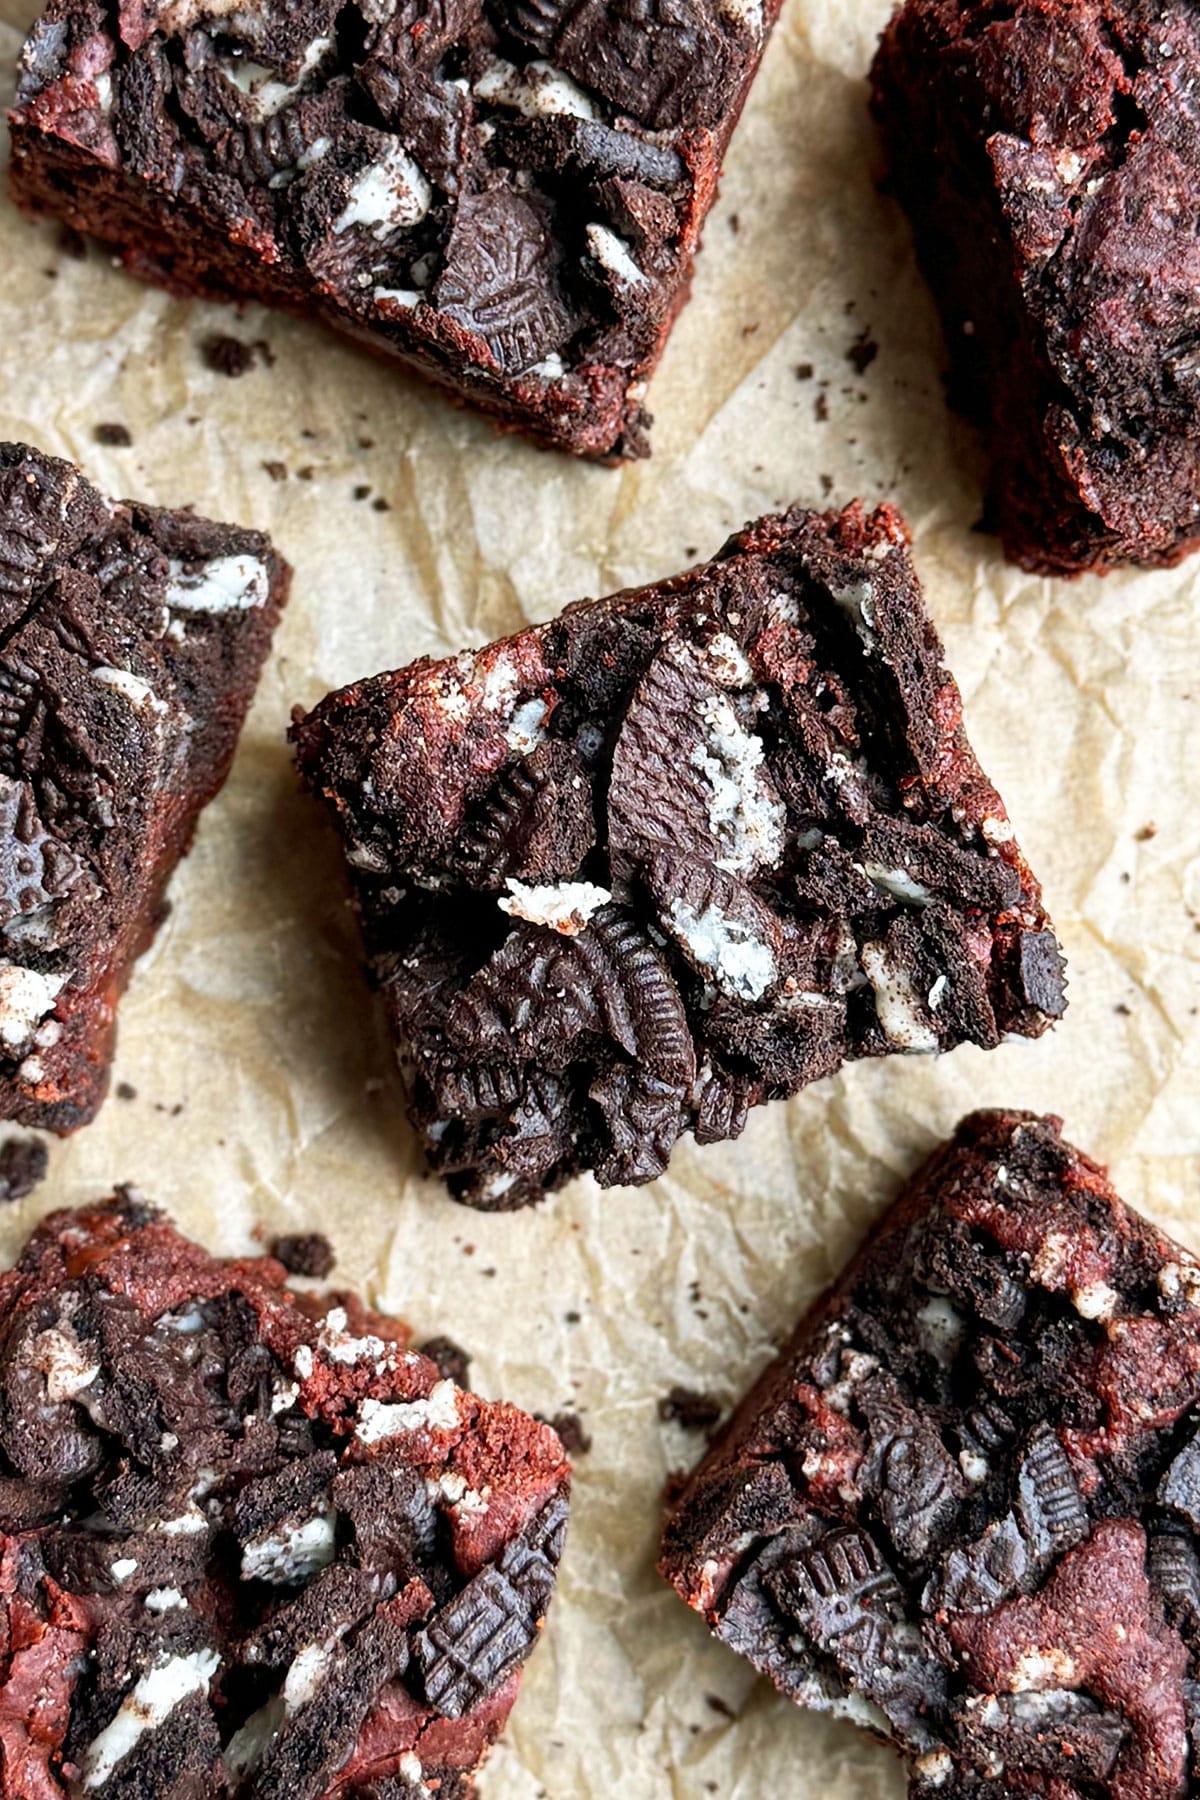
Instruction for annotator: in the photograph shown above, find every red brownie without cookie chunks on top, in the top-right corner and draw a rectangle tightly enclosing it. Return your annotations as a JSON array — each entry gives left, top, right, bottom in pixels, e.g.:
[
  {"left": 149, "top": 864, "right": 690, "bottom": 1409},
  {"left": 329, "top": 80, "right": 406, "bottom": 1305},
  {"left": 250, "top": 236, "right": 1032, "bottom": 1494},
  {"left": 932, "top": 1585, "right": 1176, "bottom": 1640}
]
[{"left": 873, "top": 0, "right": 1200, "bottom": 574}]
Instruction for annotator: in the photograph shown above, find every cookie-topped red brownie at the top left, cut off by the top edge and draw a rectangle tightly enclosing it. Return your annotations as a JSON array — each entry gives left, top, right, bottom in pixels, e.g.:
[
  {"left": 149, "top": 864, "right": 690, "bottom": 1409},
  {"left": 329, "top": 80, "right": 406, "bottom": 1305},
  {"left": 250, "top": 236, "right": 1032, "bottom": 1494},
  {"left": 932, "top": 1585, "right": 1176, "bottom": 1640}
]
[{"left": 13, "top": 0, "right": 779, "bottom": 457}]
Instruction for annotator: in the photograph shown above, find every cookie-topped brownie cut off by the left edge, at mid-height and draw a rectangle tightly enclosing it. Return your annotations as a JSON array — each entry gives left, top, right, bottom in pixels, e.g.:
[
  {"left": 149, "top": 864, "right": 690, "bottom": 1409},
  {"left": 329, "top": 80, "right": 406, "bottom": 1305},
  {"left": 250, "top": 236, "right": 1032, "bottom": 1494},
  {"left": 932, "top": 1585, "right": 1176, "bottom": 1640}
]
[{"left": 0, "top": 445, "right": 290, "bottom": 1130}]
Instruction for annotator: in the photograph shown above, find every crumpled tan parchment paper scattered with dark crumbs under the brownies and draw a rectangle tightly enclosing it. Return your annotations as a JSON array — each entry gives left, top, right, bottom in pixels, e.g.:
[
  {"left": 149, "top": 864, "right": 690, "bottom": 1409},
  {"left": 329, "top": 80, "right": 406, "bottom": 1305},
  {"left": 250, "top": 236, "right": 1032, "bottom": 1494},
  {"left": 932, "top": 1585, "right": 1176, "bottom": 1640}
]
[{"left": 0, "top": 0, "right": 1200, "bottom": 1800}]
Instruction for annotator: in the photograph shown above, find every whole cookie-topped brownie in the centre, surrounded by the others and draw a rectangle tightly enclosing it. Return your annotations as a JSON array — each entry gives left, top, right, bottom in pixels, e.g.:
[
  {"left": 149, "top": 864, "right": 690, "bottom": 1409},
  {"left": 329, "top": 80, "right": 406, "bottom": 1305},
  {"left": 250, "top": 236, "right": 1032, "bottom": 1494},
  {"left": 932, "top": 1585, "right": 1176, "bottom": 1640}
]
[{"left": 293, "top": 506, "right": 1063, "bottom": 1208}]
